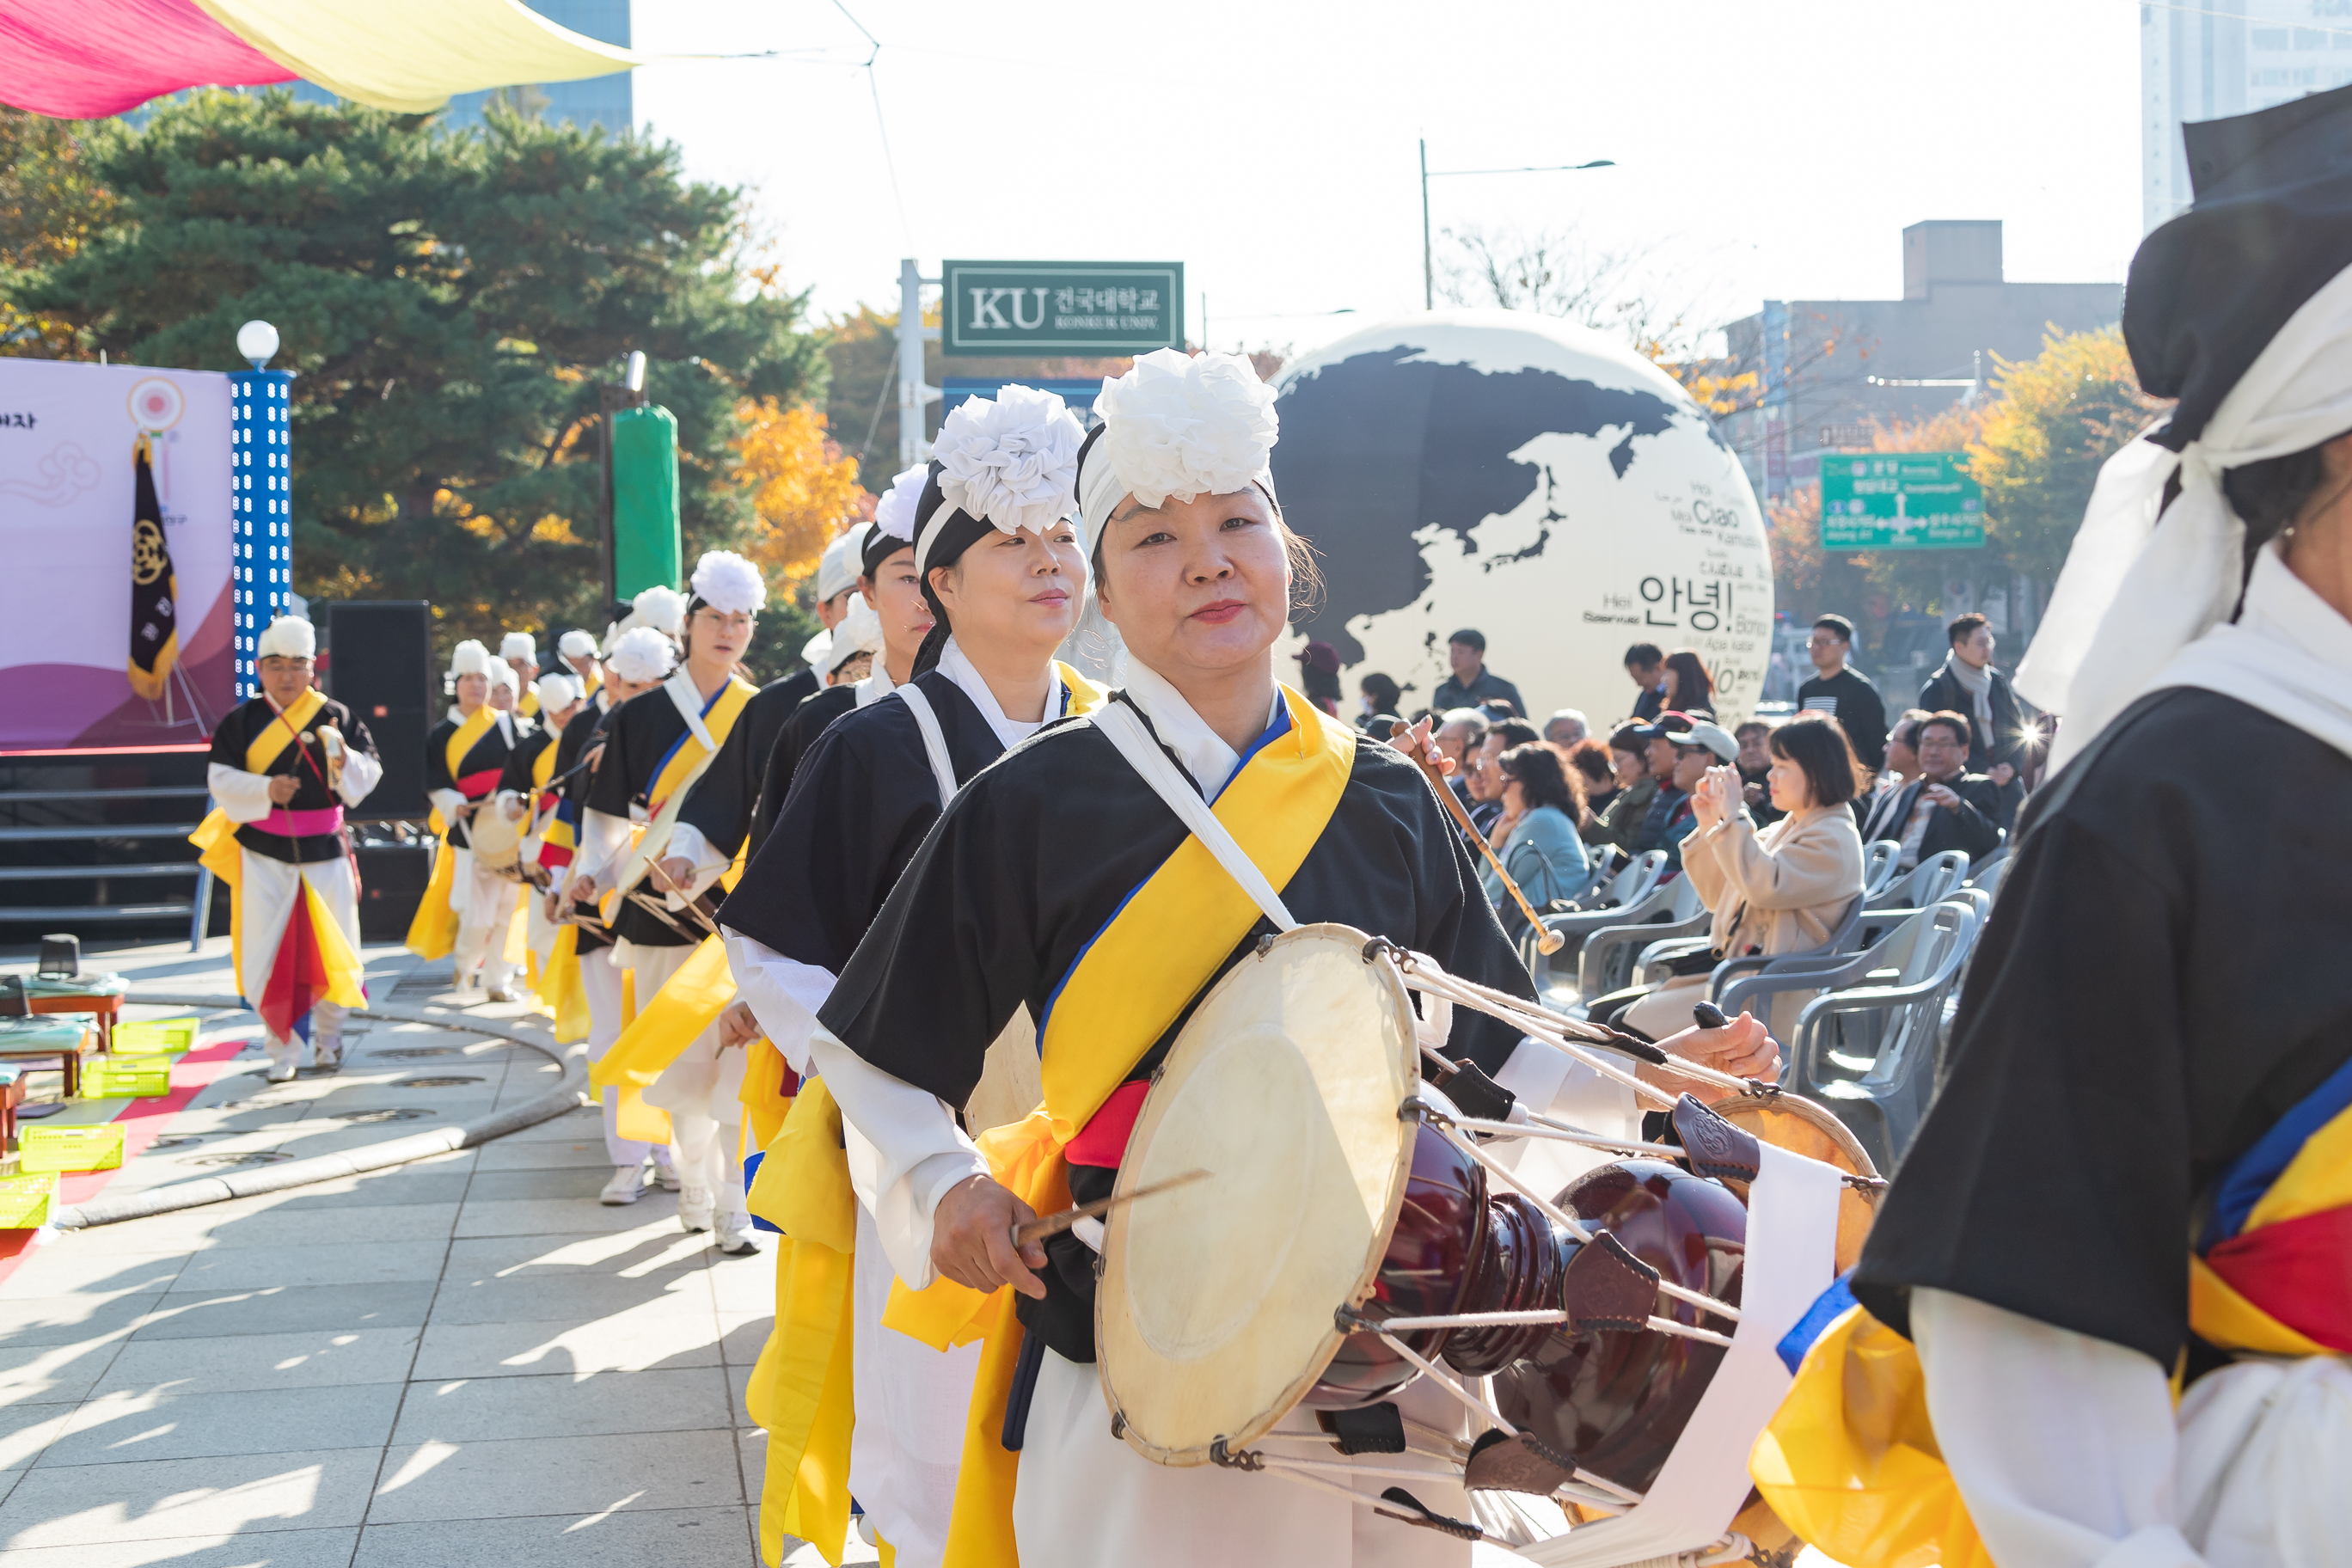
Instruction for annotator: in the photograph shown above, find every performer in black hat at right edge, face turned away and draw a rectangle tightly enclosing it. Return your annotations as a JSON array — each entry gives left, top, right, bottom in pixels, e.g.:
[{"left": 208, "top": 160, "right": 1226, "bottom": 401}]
[{"left": 1757, "top": 89, "right": 2352, "bottom": 1568}]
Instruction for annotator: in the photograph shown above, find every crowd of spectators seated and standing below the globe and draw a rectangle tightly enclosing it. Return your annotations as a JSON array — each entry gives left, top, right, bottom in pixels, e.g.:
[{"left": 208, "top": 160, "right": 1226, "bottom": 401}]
[{"left": 1344, "top": 614, "right": 2042, "bottom": 959}]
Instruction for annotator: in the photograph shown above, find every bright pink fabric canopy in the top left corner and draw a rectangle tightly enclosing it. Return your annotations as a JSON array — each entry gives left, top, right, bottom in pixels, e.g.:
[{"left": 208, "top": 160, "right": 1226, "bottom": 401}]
[{"left": 0, "top": 0, "right": 294, "bottom": 119}]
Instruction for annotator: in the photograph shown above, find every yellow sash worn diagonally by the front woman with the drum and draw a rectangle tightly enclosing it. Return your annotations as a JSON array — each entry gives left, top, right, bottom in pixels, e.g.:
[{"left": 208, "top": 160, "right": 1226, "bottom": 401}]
[{"left": 879, "top": 687, "right": 1355, "bottom": 1568}]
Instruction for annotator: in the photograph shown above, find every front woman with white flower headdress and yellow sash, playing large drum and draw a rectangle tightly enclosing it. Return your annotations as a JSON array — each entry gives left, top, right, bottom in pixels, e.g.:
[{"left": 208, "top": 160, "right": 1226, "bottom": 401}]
[{"left": 726, "top": 352, "right": 1768, "bottom": 1568}]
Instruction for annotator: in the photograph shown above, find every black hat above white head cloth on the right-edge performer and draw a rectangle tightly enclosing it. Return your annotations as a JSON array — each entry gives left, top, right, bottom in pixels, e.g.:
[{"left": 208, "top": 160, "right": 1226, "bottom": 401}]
[{"left": 2124, "top": 87, "right": 2352, "bottom": 451}]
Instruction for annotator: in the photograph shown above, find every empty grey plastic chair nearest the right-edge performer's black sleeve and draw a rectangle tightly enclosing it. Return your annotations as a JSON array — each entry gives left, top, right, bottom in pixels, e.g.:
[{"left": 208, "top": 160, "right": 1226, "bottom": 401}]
[{"left": 1767, "top": 898, "right": 1981, "bottom": 1171}]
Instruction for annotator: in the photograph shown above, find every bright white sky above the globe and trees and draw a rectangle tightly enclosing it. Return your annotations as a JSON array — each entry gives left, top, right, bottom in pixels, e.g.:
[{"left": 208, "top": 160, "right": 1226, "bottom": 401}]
[{"left": 633, "top": 0, "right": 2141, "bottom": 364}]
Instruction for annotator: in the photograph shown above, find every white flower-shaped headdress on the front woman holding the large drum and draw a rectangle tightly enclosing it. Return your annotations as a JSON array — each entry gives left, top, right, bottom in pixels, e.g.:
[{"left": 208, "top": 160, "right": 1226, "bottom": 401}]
[{"left": 1077, "top": 348, "right": 1282, "bottom": 534}]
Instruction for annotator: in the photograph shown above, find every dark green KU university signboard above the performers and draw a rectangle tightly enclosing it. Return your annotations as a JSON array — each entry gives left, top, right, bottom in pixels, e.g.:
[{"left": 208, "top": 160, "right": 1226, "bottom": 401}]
[{"left": 939, "top": 261, "right": 1183, "bottom": 358}]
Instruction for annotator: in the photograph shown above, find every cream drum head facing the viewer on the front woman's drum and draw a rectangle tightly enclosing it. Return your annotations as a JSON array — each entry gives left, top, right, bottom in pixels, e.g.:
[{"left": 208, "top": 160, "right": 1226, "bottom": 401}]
[{"left": 1093, "top": 926, "right": 1421, "bottom": 1465}]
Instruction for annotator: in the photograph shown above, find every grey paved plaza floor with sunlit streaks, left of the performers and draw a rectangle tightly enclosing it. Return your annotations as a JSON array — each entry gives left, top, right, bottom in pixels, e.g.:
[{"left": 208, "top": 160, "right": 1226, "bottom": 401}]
[{"left": 0, "top": 938, "right": 873, "bottom": 1568}]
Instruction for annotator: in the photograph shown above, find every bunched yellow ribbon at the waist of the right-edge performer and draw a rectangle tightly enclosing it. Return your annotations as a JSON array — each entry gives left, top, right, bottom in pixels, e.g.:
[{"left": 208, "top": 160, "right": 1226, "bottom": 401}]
[{"left": 1748, "top": 1307, "right": 1992, "bottom": 1568}]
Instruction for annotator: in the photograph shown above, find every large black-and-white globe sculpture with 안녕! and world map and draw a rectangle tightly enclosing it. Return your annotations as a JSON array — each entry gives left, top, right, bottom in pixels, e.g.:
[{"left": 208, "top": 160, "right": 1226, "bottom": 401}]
[{"left": 1272, "top": 310, "right": 1773, "bottom": 731}]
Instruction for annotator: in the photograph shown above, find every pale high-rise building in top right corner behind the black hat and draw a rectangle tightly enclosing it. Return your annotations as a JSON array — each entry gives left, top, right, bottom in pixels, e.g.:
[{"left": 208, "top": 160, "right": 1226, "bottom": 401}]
[{"left": 2141, "top": 0, "right": 2352, "bottom": 228}]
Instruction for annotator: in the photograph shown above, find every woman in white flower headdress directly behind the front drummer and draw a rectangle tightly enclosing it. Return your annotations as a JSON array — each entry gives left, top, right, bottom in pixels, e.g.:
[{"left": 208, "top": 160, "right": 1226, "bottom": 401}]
[{"left": 720, "top": 388, "right": 1103, "bottom": 1568}]
